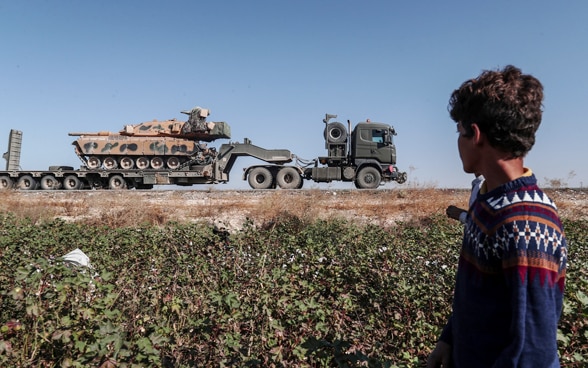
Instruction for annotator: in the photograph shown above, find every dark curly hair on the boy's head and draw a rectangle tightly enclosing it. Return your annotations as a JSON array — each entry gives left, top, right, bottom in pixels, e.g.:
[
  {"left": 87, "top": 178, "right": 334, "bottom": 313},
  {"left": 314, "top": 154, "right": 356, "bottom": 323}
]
[{"left": 448, "top": 65, "right": 543, "bottom": 158}]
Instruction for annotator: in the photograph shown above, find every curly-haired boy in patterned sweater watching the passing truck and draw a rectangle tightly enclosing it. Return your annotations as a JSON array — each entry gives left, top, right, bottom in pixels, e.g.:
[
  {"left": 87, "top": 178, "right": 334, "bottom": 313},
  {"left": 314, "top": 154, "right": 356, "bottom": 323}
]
[{"left": 427, "top": 65, "right": 567, "bottom": 368}]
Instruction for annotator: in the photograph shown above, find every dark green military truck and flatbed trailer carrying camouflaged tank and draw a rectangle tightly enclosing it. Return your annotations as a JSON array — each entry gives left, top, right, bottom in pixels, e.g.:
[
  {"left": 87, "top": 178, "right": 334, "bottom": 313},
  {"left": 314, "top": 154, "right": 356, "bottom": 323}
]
[{"left": 0, "top": 107, "right": 406, "bottom": 190}]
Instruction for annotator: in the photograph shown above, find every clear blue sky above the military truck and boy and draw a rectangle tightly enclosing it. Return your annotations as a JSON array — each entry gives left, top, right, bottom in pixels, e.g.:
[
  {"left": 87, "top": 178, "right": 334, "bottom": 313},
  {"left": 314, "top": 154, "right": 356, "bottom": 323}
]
[{"left": 0, "top": 0, "right": 588, "bottom": 189}]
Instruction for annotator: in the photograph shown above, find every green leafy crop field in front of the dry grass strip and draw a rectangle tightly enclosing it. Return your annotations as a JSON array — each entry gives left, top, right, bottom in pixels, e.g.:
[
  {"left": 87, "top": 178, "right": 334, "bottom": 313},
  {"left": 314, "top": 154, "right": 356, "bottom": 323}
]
[{"left": 0, "top": 214, "right": 588, "bottom": 367}]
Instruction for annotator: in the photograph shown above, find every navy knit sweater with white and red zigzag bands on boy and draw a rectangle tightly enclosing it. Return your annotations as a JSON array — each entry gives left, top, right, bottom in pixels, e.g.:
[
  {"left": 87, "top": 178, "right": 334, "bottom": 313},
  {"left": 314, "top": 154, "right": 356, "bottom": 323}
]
[{"left": 440, "top": 174, "right": 567, "bottom": 368}]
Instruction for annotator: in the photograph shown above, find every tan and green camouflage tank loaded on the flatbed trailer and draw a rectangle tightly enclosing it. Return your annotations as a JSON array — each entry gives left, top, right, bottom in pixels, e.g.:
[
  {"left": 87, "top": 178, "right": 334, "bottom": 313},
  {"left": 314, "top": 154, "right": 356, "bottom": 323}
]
[{"left": 69, "top": 107, "right": 231, "bottom": 170}]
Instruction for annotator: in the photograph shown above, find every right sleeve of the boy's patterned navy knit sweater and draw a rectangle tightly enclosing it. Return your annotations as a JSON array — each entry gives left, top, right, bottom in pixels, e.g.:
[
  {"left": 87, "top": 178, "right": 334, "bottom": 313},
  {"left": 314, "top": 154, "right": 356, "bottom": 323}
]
[{"left": 494, "top": 221, "right": 565, "bottom": 368}]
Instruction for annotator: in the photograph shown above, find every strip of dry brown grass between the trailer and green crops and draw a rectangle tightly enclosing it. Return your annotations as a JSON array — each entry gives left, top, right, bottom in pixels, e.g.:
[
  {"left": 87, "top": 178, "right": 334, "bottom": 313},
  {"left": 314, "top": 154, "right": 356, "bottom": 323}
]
[{"left": 0, "top": 188, "right": 588, "bottom": 228}]
